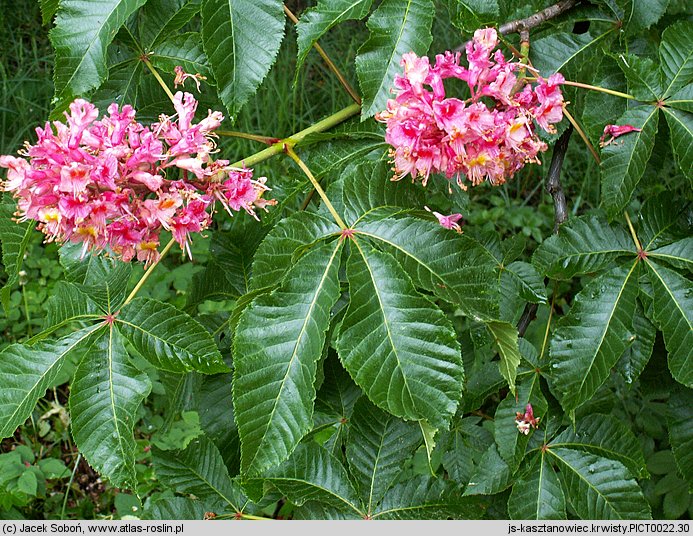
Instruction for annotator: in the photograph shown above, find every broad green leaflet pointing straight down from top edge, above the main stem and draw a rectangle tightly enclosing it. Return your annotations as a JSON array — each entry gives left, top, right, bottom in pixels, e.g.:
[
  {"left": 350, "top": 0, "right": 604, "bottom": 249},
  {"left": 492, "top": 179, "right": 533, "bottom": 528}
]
[{"left": 202, "top": 0, "right": 284, "bottom": 119}]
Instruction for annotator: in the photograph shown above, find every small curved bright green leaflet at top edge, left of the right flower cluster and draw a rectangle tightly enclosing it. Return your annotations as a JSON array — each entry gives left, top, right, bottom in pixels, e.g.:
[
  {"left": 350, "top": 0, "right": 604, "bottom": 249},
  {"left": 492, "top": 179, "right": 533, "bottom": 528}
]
[{"left": 296, "top": 0, "right": 373, "bottom": 73}]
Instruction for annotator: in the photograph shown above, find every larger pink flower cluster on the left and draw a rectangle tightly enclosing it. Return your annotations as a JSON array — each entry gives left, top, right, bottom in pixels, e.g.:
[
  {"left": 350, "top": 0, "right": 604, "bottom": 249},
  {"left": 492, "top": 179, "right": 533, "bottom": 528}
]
[{"left": 0, "top": 92, "right": 275, "bottom": 264}]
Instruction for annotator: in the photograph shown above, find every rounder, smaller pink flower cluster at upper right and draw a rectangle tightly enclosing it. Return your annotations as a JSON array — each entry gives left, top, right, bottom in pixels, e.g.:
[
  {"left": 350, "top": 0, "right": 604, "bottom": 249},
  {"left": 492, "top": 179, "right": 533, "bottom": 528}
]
[{"left": 376, "top": 28, "right": 565, "bottom": 190}]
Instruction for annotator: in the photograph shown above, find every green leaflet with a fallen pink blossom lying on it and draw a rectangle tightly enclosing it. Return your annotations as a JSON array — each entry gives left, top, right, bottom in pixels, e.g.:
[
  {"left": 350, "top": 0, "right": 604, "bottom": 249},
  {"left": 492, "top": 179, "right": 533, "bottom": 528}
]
[{"left": 601, "top": 106, "right": 659, "bottom": 219}]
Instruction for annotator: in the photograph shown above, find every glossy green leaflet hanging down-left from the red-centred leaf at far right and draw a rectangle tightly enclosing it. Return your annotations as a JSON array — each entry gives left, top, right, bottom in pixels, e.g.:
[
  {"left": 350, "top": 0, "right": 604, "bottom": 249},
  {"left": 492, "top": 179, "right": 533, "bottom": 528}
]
[{"left": 550, "top": 263, "right": 638, "bottom": 411}]
